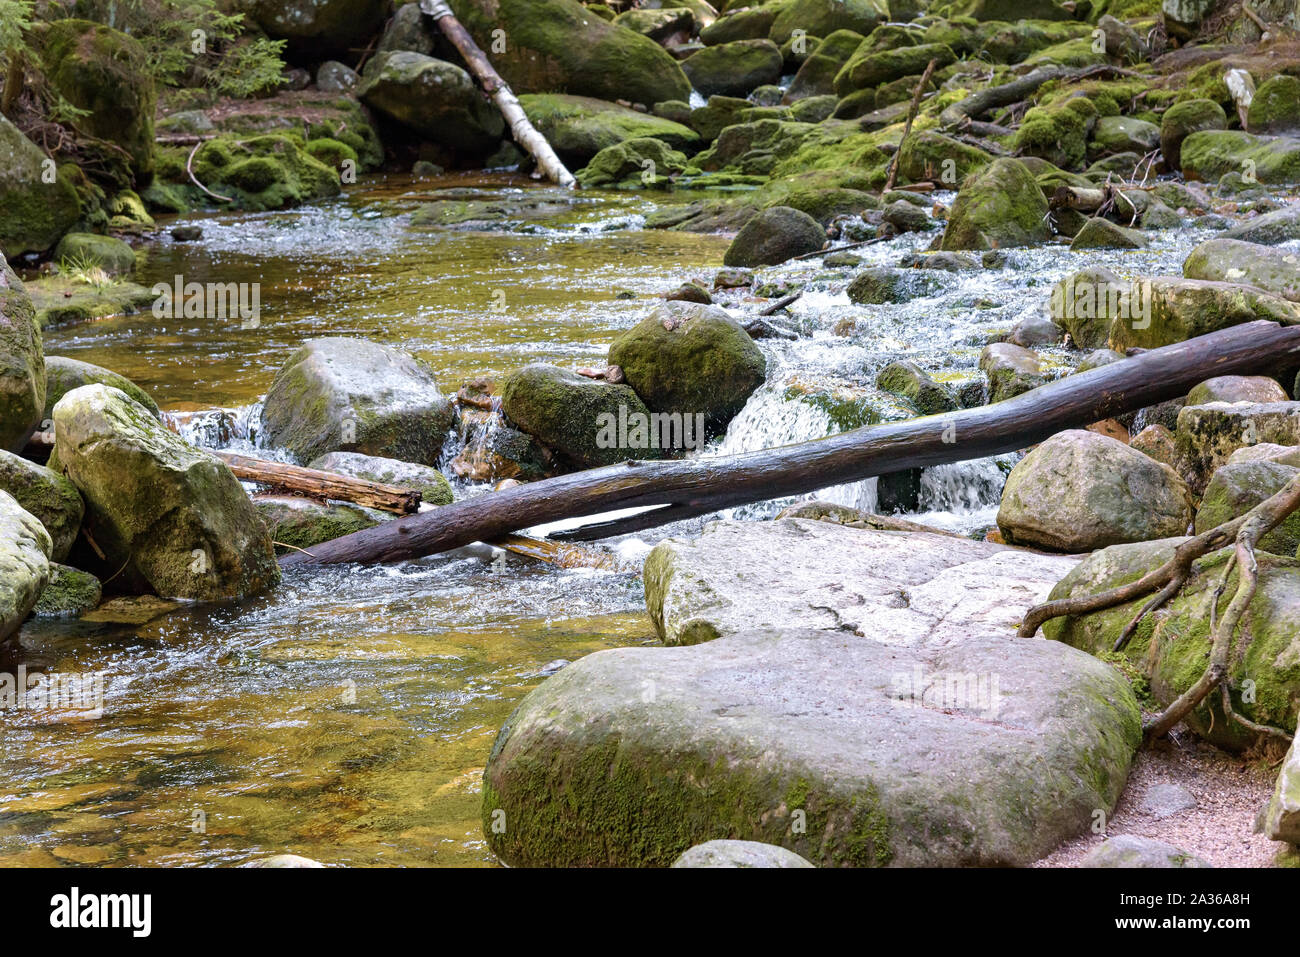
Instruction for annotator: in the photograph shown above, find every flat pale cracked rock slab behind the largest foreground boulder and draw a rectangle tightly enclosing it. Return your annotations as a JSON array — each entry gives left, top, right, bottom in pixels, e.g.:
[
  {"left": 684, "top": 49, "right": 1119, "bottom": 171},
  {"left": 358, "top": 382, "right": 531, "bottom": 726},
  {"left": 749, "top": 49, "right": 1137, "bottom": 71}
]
[{"left": 645, "top": 519, "right": 1079, "bottom": 645}]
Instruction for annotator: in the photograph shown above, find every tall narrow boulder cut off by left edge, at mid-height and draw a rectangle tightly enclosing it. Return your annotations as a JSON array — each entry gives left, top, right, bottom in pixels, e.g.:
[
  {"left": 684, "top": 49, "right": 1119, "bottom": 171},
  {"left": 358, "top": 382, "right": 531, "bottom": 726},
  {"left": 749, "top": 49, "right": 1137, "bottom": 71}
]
[{"left": 0, "top": 256, "right": 46, "bottom": 451}]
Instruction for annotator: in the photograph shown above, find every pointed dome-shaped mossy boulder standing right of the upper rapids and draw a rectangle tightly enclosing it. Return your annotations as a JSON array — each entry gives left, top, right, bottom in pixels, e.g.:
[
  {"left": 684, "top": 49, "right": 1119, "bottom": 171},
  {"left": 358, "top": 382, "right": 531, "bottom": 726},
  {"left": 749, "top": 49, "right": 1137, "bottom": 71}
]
[{"left": 940, "top": 157, "right": 1052, "bottom": 251}]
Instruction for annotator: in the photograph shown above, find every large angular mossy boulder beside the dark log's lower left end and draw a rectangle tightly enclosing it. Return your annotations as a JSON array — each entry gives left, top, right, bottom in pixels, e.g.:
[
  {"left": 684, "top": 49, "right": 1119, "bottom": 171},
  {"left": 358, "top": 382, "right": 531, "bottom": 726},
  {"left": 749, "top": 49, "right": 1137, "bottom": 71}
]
[{"left": 55, "top": 385, "right": 280, "bottom": 599}]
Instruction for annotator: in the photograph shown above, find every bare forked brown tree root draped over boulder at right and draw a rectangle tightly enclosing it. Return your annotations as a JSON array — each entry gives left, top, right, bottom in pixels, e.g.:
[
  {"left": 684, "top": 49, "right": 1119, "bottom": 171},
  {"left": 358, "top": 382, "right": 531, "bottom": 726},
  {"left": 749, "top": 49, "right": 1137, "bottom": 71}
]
[{"left": 1019, "top": 476, "right": 1300, "bottom": 744}]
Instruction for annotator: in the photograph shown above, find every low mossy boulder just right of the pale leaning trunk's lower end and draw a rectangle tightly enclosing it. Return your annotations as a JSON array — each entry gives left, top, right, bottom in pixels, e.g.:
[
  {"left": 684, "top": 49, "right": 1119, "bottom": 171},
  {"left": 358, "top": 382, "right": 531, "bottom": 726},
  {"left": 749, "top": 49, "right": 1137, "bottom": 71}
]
[{"left": 519, "top": 94, "right": 699, "bottom": 166}]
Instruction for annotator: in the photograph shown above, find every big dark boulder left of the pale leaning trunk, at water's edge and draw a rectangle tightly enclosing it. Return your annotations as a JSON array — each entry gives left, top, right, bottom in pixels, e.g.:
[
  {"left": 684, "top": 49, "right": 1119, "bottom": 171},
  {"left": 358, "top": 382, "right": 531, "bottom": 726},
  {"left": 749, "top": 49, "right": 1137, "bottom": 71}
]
[{"left": 356, "top": 51, "right": 506, "bottom": 156}]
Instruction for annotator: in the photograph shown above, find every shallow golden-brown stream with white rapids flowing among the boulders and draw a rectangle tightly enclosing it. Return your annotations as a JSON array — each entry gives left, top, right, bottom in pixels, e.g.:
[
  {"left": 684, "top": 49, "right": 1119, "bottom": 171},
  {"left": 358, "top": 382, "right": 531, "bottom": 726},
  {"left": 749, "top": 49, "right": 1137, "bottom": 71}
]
[{"left": 0, "top": 176, "right": 1210, "bottom": 866}]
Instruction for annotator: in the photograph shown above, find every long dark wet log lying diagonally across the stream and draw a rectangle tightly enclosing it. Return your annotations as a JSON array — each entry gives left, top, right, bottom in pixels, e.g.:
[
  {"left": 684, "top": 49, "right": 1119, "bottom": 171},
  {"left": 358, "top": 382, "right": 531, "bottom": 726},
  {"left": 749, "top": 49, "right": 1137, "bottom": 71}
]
[{"left": 281, "top": 320, "right": 1300, "bottom": 566}]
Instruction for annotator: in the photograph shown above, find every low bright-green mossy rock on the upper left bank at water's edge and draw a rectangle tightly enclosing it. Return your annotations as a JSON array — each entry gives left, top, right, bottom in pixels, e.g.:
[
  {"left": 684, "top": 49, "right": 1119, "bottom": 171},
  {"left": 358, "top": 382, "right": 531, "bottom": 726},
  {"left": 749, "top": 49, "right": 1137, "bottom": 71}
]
[{"left": 194, "top": 134, "right": 341, "bottom": 209}]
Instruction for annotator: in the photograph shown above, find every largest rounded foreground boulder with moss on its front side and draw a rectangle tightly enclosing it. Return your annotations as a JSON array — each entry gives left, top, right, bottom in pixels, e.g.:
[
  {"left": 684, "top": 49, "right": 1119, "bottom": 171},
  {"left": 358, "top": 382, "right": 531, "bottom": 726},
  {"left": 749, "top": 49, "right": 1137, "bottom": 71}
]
[{"left": 482, "top": 621, "right": 1140, "bottom": 866}]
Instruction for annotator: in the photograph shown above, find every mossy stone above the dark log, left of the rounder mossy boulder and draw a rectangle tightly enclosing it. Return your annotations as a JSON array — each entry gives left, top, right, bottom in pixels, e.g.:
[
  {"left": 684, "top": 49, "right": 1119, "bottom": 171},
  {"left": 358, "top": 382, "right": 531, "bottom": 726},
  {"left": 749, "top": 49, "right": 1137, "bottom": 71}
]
[{"left": 501, "top": 363, "right": 660, "bottom": 468}]
